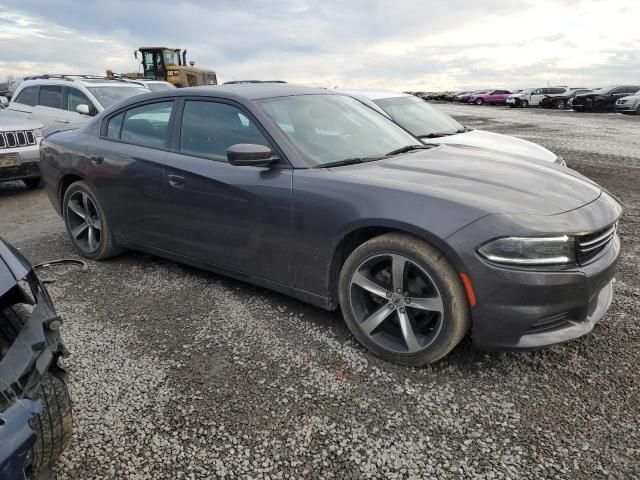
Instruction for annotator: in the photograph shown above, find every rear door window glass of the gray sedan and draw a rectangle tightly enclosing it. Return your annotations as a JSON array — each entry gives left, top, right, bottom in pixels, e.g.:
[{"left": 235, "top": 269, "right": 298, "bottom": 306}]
[{"left": 119, "top": 101, "right": 173, "bottom": 148}]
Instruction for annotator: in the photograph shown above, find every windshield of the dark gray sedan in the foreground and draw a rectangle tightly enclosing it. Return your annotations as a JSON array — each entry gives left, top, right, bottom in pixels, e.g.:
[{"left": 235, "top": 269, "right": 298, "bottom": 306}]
[{"left": 260, "top": 95, "right": 422, "bottom": 166}]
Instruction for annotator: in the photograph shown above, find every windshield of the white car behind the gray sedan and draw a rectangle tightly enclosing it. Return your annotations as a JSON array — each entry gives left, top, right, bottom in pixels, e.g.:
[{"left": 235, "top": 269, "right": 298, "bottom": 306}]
[{"left": 374, "top": 97, "right": 464, "bottom": 137}]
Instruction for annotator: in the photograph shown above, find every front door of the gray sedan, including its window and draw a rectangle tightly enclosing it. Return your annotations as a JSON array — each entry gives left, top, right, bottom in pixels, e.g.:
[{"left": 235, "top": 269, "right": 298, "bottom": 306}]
[{"left": 165, "top": 99, "right": 292, "bottom": 284}]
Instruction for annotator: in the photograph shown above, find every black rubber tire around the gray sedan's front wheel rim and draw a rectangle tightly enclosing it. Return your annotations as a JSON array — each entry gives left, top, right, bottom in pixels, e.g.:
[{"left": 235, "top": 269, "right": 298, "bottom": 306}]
[{"left": 338, "top": 233, "right": 470, "bottom": 367}]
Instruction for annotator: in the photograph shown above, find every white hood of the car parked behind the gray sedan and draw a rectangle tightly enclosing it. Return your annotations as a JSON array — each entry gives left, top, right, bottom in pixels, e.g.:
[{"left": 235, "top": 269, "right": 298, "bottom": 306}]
[{"left": 423, "top": 130, "right": 558, "bottom": 163}]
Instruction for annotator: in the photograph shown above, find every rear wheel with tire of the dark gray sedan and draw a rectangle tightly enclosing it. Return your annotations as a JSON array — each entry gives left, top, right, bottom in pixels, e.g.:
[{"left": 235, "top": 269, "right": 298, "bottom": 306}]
[{"left": 62, "top": 181, "right": 122, "bottom": 260}]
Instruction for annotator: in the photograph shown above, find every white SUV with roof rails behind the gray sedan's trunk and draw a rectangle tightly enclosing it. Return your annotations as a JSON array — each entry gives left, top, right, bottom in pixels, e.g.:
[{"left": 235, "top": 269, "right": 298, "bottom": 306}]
[{"left": 8, "top": 75, "right": 150, "bottom": 127}]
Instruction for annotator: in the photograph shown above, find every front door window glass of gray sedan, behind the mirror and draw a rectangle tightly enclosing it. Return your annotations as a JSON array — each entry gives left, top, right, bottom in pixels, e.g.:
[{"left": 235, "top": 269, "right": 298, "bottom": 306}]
[{"left": 180, "top": 100, "right": 269, "bottom": 162}]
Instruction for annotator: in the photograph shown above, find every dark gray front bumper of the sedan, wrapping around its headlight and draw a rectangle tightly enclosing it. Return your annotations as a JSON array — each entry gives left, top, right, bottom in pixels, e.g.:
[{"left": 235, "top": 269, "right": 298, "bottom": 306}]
[{"left": 450, "top": 192, "right": 622, "bottom": 350}]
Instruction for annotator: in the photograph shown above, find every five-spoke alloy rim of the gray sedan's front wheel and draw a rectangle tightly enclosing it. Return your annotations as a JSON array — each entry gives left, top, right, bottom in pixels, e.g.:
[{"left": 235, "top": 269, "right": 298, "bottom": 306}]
[{"left": 349, "top": 254, "right": 444, "bottom": 354}]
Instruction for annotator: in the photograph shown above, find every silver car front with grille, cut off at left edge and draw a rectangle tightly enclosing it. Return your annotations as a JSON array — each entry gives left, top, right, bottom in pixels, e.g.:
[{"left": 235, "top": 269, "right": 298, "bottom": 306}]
[{"left": 0, "top": 110, "right": 42, "bottom": 188}]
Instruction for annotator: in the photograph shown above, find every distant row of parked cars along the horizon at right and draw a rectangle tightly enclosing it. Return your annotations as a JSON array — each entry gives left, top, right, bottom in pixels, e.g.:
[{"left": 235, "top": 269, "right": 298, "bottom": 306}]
[{"left": 406, "top": 85, "right": 640, "bottom": 115}]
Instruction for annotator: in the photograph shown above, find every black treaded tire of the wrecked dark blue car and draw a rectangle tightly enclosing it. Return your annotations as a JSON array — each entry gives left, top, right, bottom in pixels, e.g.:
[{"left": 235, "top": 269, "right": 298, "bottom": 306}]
[{"left": 0, "top": 305, "right": 73, "bottom": 477}]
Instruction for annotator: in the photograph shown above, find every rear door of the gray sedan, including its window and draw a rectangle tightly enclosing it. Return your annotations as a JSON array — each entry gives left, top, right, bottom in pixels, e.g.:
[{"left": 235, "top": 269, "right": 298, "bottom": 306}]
[{"left": 86, "top": 99, "right": 174, "bottom": 249}]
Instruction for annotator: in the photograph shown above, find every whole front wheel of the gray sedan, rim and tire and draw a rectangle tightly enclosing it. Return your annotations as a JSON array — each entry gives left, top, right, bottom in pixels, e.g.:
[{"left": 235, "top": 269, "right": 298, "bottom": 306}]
[{"left": 339, "top": 233, "right": 469, "bottom": 366}]
